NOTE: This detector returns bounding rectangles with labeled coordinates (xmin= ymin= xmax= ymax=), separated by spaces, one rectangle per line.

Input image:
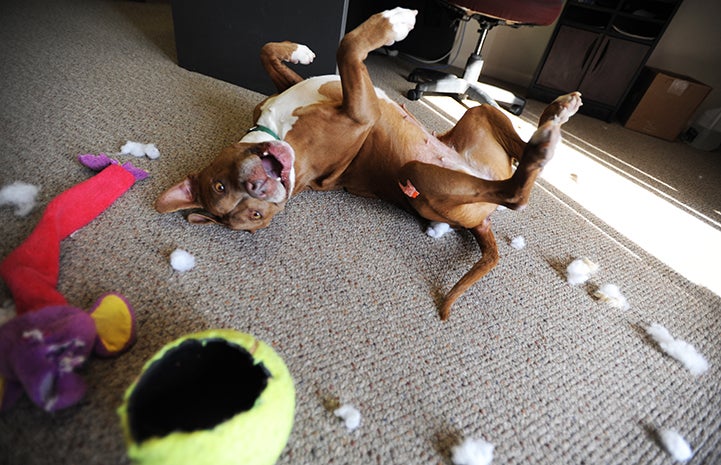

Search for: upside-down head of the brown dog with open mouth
xmin=155 ymin=141 xmax=295 ymax=232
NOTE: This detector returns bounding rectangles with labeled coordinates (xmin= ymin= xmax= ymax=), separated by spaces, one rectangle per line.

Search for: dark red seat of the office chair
xmin=448 ymin=0 xmax=563 ymax=26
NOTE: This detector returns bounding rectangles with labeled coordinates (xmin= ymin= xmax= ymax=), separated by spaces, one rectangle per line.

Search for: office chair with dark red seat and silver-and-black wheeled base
xmin=407 ymin=0 xmax=563 ymax=115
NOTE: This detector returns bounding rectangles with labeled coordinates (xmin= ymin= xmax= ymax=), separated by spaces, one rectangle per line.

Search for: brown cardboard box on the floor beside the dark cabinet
xmin=619 ymin=67 xmax=711 ymax=140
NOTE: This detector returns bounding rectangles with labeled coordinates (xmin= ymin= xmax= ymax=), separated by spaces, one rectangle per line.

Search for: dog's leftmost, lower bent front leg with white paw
xmin=260 ymin=42 xmax=315 ymax=92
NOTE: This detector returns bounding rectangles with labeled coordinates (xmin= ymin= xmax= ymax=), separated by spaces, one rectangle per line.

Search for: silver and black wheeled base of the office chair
xmin=407 ymin=68 xmax=526 ymax=115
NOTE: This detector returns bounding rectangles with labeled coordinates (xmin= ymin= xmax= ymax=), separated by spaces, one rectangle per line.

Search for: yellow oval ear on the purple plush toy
xmin=90 ymin=294 xmax=134 ymax=354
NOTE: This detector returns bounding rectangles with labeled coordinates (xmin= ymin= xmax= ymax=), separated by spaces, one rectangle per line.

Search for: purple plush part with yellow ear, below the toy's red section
xmin=0 ymin=294 xmax=135 ymax=412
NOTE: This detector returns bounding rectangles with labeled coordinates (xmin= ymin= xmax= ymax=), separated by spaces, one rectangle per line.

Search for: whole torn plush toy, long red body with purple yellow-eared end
xmin=0 ymin=159 xmax=147 ymax=411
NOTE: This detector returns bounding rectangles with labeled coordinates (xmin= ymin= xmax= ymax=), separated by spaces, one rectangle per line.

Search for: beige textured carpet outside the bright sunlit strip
xmin=0 ymin=0 xmax=721 ymax=465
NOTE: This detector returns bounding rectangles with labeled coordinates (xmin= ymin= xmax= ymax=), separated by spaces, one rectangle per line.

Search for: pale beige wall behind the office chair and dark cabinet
xmin=453 ymin=0 xmax=721 ymax=115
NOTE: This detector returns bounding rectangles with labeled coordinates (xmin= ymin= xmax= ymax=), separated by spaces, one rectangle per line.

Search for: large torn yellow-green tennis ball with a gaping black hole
xmin=118 ymin=330 xmax=295 ymax=465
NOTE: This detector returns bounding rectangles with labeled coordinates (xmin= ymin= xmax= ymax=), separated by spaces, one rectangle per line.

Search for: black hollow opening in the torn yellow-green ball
xmin=128 ymin=338 xmax=270 ymax=443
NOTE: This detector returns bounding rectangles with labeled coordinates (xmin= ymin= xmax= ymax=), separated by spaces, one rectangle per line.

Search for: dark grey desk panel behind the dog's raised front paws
xmin=171 ymin=0 xmax=348 ymax=94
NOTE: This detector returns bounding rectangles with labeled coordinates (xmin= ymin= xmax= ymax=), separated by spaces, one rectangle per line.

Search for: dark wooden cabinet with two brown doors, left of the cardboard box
xmin=528 ymin=0 xmax=681 ymax=121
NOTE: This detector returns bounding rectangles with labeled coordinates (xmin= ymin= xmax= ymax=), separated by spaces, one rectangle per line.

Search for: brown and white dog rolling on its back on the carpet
xmin=155 ymin=8 xmax=581 ymax=320
